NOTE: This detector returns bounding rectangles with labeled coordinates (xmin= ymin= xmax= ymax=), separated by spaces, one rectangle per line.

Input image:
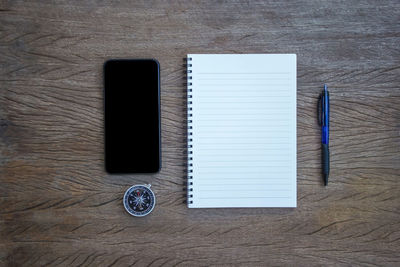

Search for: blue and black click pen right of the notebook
xmin=318 ymin=84 xmax=329 ymax=185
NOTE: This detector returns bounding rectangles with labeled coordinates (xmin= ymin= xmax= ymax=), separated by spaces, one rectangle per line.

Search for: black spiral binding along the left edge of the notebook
xmin=186 ymin=57 xmax=193 ymax=205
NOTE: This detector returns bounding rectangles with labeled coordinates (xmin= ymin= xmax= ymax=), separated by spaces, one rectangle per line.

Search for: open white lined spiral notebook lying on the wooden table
xmin=187 ymin=54 xmax=297 ymax=208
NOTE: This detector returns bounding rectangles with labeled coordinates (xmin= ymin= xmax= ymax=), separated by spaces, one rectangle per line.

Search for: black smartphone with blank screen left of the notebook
xmin=104 ymin=59 xmax=161 ymax=173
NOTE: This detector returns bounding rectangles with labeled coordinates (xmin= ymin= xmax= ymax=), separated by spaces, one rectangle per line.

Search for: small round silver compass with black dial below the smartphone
xmin=123 ymin=184 xmax=156 ymax=217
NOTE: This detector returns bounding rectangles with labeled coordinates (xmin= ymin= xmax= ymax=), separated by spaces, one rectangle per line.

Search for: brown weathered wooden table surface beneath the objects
xmin=0 ymin=0 xmax=400 ymax=266
